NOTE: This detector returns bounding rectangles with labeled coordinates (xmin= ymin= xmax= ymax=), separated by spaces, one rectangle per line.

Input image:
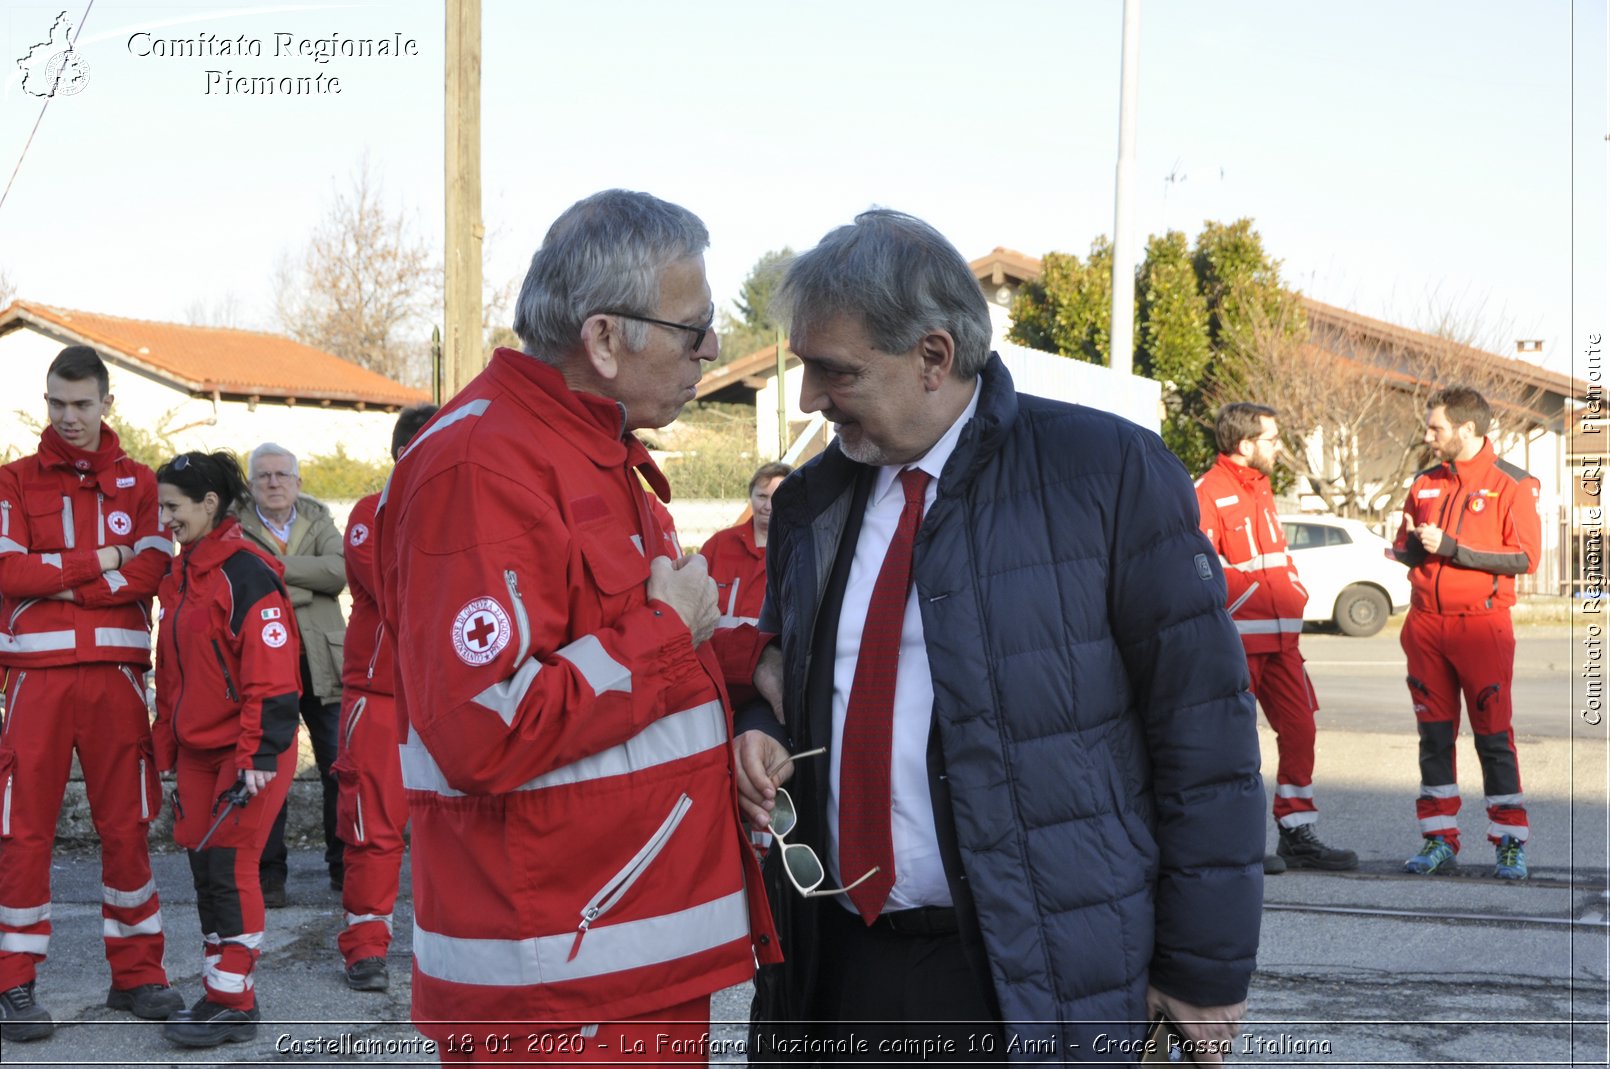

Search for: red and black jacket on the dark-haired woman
xmin=151 ymin=517 xmax=301 ymax=771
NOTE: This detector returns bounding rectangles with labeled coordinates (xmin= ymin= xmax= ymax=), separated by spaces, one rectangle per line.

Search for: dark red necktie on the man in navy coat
xmin=839 ymin=468 xmax=929 ymax=924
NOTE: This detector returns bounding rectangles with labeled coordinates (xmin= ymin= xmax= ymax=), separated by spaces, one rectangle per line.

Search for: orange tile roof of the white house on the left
xmin=0 ymin=301 xmax=430 ymax=406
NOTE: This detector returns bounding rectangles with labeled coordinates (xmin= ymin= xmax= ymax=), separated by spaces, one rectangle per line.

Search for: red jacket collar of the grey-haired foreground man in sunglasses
xmin=486 ymin=349 xmax=671 ymax=501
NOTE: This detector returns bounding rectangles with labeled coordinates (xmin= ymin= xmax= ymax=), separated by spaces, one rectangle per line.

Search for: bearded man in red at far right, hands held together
xmin=1393 ymin=386 xmax=1542 ymax=879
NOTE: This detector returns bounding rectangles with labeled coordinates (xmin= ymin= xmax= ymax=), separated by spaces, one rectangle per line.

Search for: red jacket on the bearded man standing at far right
xmin=1393 ymin=441 xmax=1542 ymax=615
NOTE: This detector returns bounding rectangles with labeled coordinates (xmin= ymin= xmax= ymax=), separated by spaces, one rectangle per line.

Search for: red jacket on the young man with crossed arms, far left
xmin=0 ymin=423 xmax=174 ymax=670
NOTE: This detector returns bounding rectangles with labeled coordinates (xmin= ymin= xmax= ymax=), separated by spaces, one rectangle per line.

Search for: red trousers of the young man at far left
xmin=0 ymin=663 xmax=167 ymax=990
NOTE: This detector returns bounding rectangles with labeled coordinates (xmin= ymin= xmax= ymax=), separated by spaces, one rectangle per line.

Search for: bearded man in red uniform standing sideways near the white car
xmin=1196 ymin=402 xmax=1359 ymax=874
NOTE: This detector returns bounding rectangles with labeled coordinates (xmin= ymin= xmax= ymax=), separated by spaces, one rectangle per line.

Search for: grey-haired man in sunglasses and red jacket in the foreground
xmin=375 ymin=190 xmax=779 ymax=1064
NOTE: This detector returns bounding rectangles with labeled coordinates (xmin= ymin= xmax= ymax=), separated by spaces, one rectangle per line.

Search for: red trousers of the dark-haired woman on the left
xmin=174 ymin=734 xmax=296 ymax=1009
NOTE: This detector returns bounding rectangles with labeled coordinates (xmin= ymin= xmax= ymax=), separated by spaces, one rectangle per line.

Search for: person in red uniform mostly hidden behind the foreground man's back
xmin=335 ymin=404 xmax=436 ymax=992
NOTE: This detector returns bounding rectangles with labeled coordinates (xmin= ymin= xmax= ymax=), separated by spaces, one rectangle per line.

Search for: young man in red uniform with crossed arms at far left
xmin=0 ymin=346 xmax=184 ymax=1042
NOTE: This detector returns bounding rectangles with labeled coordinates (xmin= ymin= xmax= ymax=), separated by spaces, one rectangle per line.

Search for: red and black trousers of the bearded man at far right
xmin=1399 ymin=609 xmax=1530 ymax=853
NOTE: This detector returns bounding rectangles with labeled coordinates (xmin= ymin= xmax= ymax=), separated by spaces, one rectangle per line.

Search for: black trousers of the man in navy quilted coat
xmin=815 ymin=902 xmax=1006 ymax=1066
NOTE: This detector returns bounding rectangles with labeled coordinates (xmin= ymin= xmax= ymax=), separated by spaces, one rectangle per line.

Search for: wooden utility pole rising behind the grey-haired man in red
xmin=443 ymin=0 xmax=486 ymax=401
